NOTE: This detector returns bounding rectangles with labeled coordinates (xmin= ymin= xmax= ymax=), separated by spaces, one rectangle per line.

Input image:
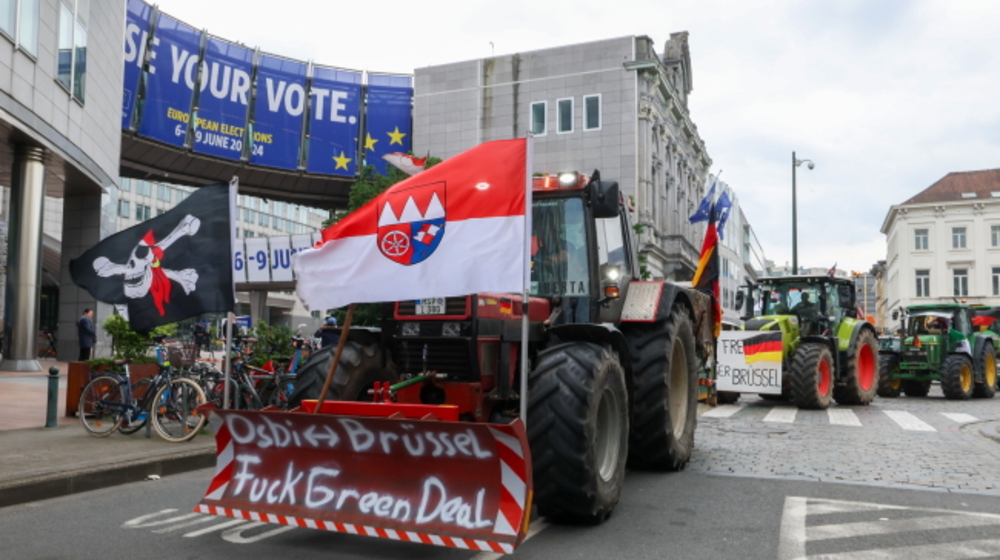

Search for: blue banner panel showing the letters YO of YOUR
xmin=139 ymin=14 xmax=201 ymax=147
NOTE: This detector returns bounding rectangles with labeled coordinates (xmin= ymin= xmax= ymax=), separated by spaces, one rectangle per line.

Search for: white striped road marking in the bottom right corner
xmin=778 ymin=496 xmax=1000 ymax=560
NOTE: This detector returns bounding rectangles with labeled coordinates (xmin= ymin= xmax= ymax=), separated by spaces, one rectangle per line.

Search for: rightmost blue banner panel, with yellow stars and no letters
xmin=364 ymin=74 xmax=413 ymax=175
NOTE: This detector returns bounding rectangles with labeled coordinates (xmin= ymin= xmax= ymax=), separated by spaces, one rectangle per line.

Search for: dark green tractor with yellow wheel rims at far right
xmin=878 ymin=303 xmax=1000 ymax=400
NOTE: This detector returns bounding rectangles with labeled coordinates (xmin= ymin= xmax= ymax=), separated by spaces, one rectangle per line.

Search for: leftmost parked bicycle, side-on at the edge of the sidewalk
xmin=78 ymin=350 xmax=208 ymax=442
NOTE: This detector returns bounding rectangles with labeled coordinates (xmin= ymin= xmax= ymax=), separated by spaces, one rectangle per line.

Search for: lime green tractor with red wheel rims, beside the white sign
xmin=737 ymin=275 xmax=879 ymax=409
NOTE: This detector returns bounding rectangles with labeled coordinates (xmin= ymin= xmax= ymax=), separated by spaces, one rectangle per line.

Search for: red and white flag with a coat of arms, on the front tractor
xmin=292 ymin=139 xmax=531 ymax=310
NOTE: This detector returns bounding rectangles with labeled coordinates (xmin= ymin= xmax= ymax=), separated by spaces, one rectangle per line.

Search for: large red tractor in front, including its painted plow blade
xmin=199 ymin=172 xmax=715 ymax=551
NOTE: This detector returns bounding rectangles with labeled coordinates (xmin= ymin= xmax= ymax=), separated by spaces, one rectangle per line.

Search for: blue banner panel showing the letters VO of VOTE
xmin=250 ymin=55 xmax=307 ymax=169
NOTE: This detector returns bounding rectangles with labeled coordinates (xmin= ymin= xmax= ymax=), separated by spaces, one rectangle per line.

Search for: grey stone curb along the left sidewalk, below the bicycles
xmin=0 ymin=448 xmax=215 ymax=508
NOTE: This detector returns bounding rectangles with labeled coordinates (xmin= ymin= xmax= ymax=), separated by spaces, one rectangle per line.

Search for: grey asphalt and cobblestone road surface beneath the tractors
xmin=0 ymin=384 xmax=1000 ymax=560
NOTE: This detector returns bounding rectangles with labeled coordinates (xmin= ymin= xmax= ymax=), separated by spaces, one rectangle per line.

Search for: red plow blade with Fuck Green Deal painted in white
xmin=194 ymin=401 xmax=532 ymax=553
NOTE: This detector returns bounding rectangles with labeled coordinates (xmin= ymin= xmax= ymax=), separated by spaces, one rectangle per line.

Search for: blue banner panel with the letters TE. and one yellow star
xmin=306 ymin=66 xmax=362 ymax=177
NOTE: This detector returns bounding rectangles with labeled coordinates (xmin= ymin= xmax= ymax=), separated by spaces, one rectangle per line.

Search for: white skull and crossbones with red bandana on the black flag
xmin=94 ymin=214 xmax=201 ymax=317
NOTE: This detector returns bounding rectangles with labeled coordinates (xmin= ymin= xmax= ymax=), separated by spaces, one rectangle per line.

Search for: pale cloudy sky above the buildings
xmin=158 ymin=0 xmax=1000 ymax=271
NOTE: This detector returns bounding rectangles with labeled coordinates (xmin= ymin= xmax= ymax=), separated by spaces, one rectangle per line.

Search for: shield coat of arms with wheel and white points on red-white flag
xmin=377 ymin=182 xmax=446 ymax=265
